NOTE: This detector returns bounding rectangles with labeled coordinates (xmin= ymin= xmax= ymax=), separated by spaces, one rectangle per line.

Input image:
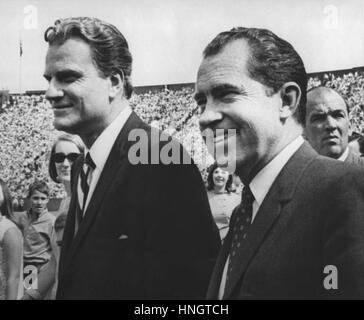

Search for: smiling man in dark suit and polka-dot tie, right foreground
xmin=195 ymin=27 xmax=364 ymax=299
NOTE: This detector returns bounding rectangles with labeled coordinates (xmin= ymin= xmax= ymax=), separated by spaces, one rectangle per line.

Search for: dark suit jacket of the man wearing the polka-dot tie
xmin=207 ymin=143 xmax=364 ymax=299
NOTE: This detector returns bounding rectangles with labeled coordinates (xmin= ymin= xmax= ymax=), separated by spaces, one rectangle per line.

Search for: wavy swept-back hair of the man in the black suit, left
xmin=44 ymin=17 xmax=133 ymax=99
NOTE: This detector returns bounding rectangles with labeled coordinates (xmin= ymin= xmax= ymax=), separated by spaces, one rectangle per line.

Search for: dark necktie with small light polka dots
xmin=226 ymin=186 xmax=254 ymax=288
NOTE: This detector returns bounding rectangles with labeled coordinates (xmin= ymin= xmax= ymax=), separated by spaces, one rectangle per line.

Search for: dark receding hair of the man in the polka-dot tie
xmin=203 ymin=27 xmax=307 ymax=125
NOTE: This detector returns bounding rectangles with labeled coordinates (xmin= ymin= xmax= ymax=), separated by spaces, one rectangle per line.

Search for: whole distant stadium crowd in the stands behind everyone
xmin=0 ymin=72 xmax=364 ymax=201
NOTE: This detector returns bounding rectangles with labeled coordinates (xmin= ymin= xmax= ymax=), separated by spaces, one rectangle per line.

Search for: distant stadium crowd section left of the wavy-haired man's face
xmin=0 ymin=96 xmax=59 ymax=199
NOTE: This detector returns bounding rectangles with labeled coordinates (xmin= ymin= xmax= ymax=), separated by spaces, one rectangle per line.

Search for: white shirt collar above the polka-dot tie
xmin=249 ymin=136 xmax=304 ymax=206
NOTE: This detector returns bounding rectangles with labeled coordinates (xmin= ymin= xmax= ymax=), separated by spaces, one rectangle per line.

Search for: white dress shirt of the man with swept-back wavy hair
xmin=77 ymin=105 xmax=132 ymax=214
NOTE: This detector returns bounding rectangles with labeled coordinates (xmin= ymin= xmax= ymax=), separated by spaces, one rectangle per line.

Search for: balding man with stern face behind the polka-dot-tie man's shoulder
xmin=305 ymin=87 xmax=364 ymax=165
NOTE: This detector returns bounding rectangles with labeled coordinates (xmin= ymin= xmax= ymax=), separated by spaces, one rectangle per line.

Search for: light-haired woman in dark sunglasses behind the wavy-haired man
xmin=49 ymin=133 xmax=85 ymax=246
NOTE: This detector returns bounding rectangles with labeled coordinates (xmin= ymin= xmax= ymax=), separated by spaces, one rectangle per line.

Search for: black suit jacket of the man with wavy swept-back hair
xmin=57 ymin=113 xmax=220 ymax=299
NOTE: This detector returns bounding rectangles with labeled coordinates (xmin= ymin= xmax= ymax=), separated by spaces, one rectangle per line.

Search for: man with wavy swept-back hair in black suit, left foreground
xmin=44 ymin=17 xmax=219 ymax=299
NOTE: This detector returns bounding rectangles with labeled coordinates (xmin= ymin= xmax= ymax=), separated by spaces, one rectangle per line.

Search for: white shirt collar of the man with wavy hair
xmin=85 ymin=105 xmax=132 ymax=171
